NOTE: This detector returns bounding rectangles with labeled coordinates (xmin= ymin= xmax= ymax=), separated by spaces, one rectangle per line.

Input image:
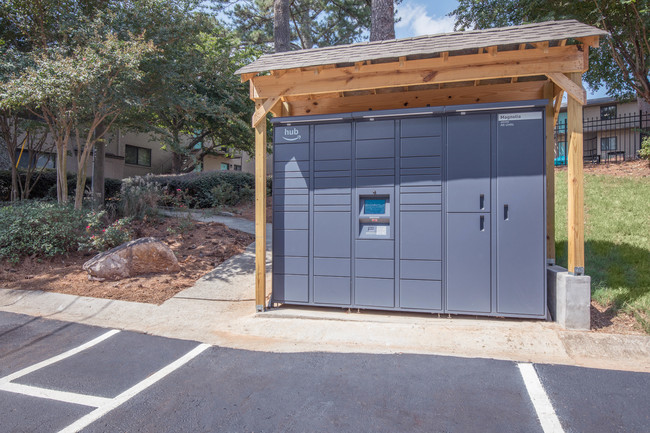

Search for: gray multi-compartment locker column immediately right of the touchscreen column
xmin=399 ymin=116 xmax=443 ymax=311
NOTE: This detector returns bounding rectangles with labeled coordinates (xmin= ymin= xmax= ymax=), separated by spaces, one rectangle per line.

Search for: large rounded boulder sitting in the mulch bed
xmin=83 ymin=238 xmax=181 ymax=281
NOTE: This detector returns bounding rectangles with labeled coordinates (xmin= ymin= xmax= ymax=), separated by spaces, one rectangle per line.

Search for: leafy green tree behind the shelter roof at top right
xmin=450 ymin=0 xmax=650 ymax=102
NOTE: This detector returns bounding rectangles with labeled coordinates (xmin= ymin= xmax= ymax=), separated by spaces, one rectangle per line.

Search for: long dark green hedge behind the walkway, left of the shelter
xmin=124 ymin=171 xmax=255 ymax=208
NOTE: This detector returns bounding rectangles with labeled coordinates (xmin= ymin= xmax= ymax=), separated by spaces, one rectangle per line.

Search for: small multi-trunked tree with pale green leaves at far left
xmin=0 ymin=11 xmax=153 ymax=209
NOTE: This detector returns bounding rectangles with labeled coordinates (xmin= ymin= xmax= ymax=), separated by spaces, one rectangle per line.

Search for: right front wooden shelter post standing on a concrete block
xmin=567 ymin=72 xmax=585 ymax=275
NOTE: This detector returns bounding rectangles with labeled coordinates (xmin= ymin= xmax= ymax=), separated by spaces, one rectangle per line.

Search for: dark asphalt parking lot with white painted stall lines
xmin=0 ymin=312 xmax=650 ymax=432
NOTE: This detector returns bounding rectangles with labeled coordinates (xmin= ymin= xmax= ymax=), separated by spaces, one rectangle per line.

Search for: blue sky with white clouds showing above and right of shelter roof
xmin=395 ymin=0 xmax=607 ymax=99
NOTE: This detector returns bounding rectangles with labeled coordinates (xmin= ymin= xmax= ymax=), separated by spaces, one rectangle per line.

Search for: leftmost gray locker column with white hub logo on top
xmin=273 ymin=126 xmax=310 ymax=303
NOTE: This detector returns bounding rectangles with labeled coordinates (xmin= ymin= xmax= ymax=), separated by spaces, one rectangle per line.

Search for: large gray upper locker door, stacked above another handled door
xmin=447 ymin=114 xmax=491 ymax=212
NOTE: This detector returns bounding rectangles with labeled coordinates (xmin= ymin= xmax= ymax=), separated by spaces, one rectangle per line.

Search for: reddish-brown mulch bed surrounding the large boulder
xmin=0 ymin=218 xmax=254 ymax=304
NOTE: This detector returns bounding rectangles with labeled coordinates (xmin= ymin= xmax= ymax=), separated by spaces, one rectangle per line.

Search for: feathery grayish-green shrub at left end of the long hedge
xmin=120 ymin=176 xmax=162 ymax=219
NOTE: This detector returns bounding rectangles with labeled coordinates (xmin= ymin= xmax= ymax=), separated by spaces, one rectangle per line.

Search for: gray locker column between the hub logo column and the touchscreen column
xmin=312 ymin=122 xmax=352 ymax=305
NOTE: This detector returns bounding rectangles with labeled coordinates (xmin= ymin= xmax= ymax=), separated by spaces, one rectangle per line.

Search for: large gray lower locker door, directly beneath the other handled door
xmin=447 ymin=213 xmax=491 ymax=313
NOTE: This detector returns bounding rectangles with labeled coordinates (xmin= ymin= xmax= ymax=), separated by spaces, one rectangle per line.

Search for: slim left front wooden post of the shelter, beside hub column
xmin=255 ymin=107 xmax=266 ymax=311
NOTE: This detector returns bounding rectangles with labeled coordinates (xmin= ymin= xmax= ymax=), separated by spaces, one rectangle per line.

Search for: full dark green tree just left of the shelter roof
xmin=130 ymin=0 xmax=254 ymax=173
